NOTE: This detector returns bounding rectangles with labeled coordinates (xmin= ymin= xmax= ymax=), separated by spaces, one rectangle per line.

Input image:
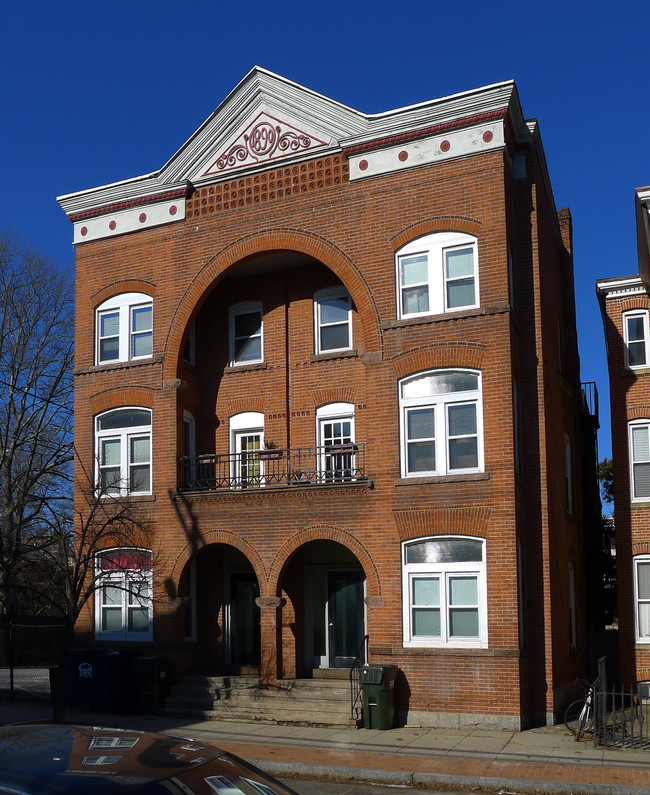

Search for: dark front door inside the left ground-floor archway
xmin=229 ymin=572 xmax=260 ymax=666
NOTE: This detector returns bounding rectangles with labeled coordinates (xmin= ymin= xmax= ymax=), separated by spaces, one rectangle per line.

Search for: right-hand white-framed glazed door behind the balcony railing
xmin=316 ymin=403 xmax=357 ymax=483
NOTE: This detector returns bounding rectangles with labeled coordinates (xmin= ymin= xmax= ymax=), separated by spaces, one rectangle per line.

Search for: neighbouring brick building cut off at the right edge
xmin=596 ymin=188 xmax=650 ymax=685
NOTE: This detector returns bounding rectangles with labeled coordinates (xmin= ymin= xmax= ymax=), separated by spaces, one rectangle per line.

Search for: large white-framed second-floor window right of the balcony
xmin=399 ymin=369 xmax=483 ymax=477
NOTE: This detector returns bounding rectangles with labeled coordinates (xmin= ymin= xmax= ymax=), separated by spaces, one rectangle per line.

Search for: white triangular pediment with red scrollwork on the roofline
xmin=160 ymin=68 xmax=368 ymax=185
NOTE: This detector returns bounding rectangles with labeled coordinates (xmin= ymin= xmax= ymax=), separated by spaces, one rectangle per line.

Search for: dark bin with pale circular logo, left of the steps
xmin=67 ymin=649 xmax=135 ymax=712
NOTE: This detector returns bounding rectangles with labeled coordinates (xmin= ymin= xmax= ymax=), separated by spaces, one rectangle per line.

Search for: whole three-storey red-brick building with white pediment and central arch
xmin=60 ymin=68 xmax=594 ymax=728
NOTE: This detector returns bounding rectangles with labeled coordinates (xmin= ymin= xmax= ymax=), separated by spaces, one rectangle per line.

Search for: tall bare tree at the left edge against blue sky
xmin=0 ymin=236 xmax=73 ymax=632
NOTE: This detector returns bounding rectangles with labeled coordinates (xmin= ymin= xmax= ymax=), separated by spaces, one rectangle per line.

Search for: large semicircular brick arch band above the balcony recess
xmin=164 ymin=229 xmax=382 ymax=378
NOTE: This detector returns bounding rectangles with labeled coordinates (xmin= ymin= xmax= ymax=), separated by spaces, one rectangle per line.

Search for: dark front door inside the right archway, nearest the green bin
xmin=327 ymin=571 xmax=364 ymax=668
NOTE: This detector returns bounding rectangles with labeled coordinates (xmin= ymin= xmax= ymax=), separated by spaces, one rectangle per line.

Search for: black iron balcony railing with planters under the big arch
xmin=180 ymin=444 xmax=368 ymax=493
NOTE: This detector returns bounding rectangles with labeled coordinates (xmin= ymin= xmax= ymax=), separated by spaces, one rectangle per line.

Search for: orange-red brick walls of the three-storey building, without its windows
xmin=61 ymin=70 xmax=592 ymax=727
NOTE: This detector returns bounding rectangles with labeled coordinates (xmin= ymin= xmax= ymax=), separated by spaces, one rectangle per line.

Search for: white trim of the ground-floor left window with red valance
xmin=95 ymin=547 xmax=153 ymax=643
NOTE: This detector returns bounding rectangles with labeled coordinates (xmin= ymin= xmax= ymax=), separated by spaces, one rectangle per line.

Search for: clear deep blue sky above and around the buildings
xmin=0 ymin=0 xmax=650 ymax=455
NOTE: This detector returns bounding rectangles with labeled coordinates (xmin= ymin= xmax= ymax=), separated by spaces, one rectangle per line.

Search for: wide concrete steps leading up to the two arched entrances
xmin=163 ymin=676 xmax=357 ymax=728
